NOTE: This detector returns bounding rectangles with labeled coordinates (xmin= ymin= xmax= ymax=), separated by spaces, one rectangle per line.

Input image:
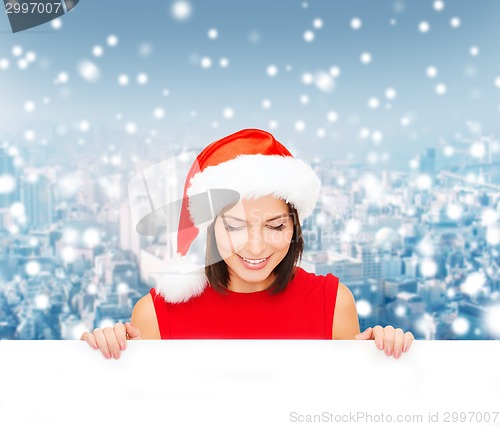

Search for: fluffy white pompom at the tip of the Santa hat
xmin=154 ymin=255 xmax=208 ymax=303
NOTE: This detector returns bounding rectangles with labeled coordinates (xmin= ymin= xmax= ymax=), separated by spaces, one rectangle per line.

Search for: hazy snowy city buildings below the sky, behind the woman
xmin=0 ymin=131 xmax=500 ymax=339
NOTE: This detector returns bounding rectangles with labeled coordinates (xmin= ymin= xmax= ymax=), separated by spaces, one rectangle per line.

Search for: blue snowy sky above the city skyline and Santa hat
xmin=0 ymin=0 xmax=500 ymax=167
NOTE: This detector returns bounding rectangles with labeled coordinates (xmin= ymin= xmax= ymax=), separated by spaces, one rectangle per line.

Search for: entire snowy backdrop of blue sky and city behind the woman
xmin=0 ymin=0 xmax=500 ymax=340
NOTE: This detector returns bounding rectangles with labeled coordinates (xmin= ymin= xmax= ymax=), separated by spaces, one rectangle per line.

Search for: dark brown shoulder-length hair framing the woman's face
xmin=205 ymin=203 xmax=304 ymax=294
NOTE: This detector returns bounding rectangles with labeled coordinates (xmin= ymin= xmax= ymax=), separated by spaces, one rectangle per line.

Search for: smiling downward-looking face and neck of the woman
xmin=215 ymin=196 xmax=293 ymax=292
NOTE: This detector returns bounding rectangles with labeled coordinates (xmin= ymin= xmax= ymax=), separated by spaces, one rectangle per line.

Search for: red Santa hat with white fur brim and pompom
xmin=155 ymin=129 xmax=320 ymax=303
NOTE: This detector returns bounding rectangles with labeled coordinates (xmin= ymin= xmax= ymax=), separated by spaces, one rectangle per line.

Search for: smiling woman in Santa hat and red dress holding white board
xmin=81 ymin=129 xmax=414 ymax=359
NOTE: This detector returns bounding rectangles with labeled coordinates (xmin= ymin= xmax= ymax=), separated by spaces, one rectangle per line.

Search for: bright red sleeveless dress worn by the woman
xmin=146 ymin=268 xmax=339 ymax=340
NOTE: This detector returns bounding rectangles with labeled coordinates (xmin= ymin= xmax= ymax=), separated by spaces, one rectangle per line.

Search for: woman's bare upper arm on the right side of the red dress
xmin=332 ymin=282 xmax=359 ymax=340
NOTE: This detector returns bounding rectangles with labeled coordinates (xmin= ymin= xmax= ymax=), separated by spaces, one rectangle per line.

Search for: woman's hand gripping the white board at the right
xmin=354 ymin=325 xmax=415 ymax=359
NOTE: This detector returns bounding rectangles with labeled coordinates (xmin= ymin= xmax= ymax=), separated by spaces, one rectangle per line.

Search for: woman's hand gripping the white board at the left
xmin=80 ymin=322 xmax=141 ymax=359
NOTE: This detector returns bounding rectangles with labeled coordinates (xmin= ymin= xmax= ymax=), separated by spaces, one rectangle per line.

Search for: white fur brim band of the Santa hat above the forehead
xmin=187 ymin=154 xmax=321 ymax=223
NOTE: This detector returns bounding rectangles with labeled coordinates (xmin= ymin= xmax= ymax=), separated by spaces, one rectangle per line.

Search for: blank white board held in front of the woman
xmin=0 ymin=340 xmax=500 ymax=426
